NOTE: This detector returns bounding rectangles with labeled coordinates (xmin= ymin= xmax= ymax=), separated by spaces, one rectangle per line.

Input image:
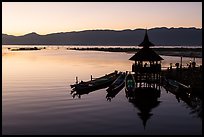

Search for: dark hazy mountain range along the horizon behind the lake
xmin=2 ymin=27 xmax=202 ymax=46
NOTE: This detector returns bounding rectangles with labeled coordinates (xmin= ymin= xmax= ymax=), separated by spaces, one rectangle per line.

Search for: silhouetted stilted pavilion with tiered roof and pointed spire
xmin=129 ymin=30 xmax=163 ymax=87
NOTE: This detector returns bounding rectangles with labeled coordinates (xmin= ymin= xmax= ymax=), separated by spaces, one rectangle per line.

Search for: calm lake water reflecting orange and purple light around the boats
xmin=2 ymin=47 xmax=202 ymax=135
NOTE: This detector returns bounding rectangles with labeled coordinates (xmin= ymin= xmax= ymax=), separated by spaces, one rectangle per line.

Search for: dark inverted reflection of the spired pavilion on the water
xmin=126 ymin=88 xmax=161 ymax=129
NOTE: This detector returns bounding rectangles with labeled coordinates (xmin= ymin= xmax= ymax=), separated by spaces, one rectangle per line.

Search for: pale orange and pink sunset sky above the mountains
xmin=2 ymin=2 xmax=202 ymax=36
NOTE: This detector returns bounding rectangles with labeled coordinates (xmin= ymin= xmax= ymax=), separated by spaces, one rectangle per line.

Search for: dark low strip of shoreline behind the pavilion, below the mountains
xmin=67 ymin=47 xmax=202 ymax=58
